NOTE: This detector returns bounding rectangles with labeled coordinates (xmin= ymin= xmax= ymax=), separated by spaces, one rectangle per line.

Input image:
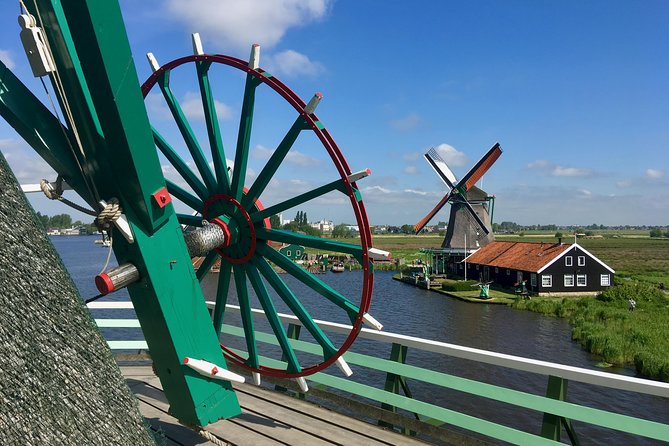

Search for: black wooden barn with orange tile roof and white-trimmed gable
xmin=458 ymin=241 xmax=615 ymax=296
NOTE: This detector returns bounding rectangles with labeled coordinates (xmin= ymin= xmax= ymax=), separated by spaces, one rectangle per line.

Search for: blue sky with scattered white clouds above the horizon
xmin=0 ymin=0 xmax=669 ymax=225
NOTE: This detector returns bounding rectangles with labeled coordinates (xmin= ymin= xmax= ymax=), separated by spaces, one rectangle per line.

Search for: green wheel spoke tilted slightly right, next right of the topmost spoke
xmin=230 ymin=74 xmax=260 ymax=201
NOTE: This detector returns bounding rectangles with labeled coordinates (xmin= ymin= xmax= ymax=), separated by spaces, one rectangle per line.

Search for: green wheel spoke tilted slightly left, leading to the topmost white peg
xmin=195 ymin=61 xmax=230 ymax=194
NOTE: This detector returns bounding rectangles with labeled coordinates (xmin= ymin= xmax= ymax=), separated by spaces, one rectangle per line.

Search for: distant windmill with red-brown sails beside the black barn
xmin=414 ymin=143 xmax=502 ymax=250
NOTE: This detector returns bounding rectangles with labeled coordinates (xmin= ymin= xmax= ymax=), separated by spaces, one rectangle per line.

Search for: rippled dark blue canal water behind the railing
xmin=52 ymin=237 xmax=669 ymax=445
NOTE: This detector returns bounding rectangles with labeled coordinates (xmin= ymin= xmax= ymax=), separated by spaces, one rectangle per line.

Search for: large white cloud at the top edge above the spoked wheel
xmin=167 ymin=0 xmax=332 ymax=52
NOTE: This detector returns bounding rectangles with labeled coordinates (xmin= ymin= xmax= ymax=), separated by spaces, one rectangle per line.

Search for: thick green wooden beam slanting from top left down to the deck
xmin=5 ymin=0 xmax=241 ymax=425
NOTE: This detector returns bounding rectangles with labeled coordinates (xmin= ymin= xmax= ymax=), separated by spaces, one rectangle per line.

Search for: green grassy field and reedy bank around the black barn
xmin=328 ymin=231 xmax=669 ymax=382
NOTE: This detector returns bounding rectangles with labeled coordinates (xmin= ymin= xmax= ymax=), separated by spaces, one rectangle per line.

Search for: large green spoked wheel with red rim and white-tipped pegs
xmin=142 ymin=42 xmax=379 ymax=378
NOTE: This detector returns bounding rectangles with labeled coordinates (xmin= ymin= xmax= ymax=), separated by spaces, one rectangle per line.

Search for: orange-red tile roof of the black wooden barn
xmin=467 ymin=242 xmax=571 ymax=272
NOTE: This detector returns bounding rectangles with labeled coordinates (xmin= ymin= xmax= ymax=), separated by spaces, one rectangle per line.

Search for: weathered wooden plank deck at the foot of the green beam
xmin=121 ymin=366 xmax=427 ymax=446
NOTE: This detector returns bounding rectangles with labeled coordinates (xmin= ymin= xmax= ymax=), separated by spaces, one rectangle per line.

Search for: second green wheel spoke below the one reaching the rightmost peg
xmin=251 ymin=256 xmax=337 ymax=359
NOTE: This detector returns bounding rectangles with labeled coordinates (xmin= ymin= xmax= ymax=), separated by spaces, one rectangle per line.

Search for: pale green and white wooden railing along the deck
xmin=89 ymin=302 xmax=669 ymax=445
